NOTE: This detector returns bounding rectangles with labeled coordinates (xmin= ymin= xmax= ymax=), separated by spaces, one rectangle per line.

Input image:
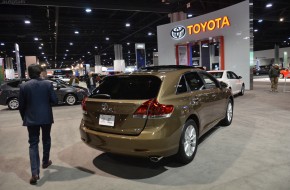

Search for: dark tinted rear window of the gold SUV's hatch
xmin=90 ymin=75 xmax=161 ymax=100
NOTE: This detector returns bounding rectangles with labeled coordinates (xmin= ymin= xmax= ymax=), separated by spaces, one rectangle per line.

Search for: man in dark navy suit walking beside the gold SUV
xmin=19 ymin=64 xmax=57 ymax=185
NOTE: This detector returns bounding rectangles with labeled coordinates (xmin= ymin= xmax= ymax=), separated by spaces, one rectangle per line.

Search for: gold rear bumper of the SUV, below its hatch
xmin=80 ymin=120 xmax=180 ymax=157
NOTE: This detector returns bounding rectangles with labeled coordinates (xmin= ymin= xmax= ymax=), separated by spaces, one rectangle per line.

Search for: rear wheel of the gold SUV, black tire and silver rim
xmin=176 ymin=119 xmax=198 ymax=164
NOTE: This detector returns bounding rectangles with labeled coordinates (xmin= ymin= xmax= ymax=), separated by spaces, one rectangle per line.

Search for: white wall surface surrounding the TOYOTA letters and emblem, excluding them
xmin=157 ymin=0 xmax=250 ymax=90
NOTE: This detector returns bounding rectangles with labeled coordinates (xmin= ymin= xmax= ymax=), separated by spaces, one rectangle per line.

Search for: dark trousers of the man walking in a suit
xmin=27 ymin=124 xmax=51 ymax=175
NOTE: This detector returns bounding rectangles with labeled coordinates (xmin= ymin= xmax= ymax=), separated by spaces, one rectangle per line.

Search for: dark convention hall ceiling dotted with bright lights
xmin=0 ymin=0 xmax=290 ymax=67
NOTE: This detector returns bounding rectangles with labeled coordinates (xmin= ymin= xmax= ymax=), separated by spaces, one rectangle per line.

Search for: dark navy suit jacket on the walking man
xmin=19 ymin=78 xmax=57 ymax=126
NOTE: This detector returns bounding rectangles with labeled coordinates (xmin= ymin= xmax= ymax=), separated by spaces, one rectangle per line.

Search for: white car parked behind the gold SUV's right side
xmin=208 ymin=70 xmax=245 ymax=96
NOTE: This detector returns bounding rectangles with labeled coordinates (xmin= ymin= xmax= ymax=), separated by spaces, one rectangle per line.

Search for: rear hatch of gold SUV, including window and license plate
xmin=83 ymin=75 xmax=162 ymax=135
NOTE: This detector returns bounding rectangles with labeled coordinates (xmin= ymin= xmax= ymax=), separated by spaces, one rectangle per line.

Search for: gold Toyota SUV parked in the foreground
xmin=80 ymin=65 xmax=234 ymax=164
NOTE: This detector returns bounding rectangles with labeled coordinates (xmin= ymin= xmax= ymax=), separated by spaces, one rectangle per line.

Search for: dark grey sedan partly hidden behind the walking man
xmin=0 ymin=79 xmax=88 ymax=110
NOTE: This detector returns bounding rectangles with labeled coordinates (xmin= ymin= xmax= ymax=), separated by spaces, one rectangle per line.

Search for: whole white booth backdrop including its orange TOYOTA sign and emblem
xmin=157 ymin=0 xmax=253 ymax=90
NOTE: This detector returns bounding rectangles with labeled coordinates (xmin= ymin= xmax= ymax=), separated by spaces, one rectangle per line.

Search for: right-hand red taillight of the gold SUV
xmin=133 ymin=99 xmax=174 ymax=118
